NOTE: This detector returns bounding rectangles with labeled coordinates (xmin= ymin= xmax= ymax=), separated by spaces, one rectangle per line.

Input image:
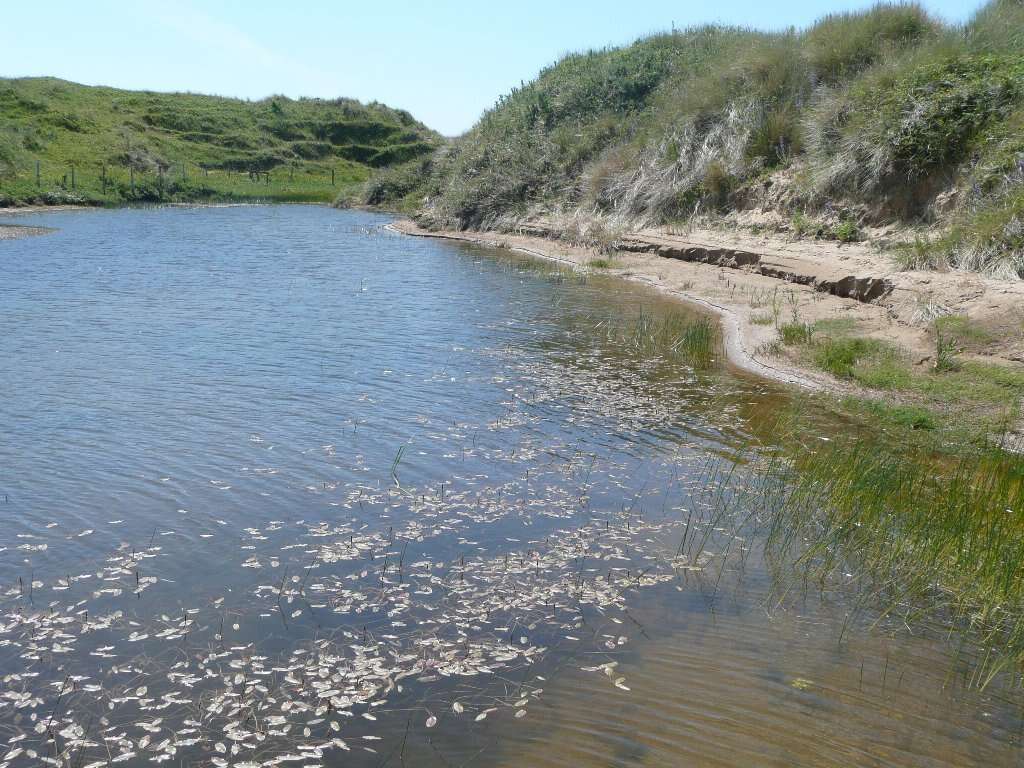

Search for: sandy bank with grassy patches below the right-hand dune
xmin=388 ymin=218 xmax=1024 ymax=421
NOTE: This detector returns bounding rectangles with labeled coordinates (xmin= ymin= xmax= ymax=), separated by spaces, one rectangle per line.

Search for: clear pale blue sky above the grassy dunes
xmin=0 ymin=0 xmax=983 ymax=134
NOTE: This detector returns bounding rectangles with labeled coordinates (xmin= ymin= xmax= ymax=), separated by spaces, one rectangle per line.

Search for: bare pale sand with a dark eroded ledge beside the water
xmin=391 ymin=220 xmax=1024 ymax=394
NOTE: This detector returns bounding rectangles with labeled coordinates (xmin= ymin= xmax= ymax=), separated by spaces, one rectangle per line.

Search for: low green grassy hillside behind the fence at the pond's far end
xmin=0 ymin=78 xmax=438 ymax=206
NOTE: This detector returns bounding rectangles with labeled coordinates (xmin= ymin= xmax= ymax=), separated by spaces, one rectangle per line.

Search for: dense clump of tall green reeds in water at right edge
xmin=730 ymin=440 xmax=1024 ymax=687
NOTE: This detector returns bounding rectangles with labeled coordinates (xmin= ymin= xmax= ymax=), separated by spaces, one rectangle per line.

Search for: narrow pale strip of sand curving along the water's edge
xmin=385 ymin=219 xmax=831 ymax=393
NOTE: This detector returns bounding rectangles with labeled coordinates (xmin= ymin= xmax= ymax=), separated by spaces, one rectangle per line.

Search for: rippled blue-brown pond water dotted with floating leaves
xmin=0 ymin=206 xmax=1021 ymax=766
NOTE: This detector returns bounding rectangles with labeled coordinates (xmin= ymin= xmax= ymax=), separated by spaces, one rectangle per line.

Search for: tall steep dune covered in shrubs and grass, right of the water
xmin=364 ymin=0 xmax=1024 ymax=276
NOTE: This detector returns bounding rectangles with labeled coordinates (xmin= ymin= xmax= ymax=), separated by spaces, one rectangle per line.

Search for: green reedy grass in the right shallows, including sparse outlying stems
xmin=679 ymin=398 xmax=1024 ymax=688
